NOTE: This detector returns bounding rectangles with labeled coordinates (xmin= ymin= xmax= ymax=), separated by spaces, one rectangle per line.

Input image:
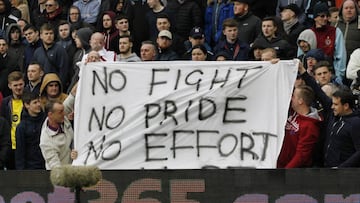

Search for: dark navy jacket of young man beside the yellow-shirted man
xmin=15 ymin=110 xmax=46 ymax=170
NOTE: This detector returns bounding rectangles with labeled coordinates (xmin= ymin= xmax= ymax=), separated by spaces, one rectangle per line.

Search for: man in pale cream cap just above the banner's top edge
xmin=156 ymin=30 xmax=179 ymax=61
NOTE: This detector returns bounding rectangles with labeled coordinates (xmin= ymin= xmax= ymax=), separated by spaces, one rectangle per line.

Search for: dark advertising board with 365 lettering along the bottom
xmin=0 ymin=168 xmax=360 ymax=203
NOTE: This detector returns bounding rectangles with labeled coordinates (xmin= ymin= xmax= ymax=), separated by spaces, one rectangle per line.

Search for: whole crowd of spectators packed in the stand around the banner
xmin=0 ymin=0 xmax=360 ymax=170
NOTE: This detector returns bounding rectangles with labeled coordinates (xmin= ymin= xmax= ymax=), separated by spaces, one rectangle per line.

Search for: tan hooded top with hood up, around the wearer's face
xmin=40 ymin=73 xmax=67 ymax=109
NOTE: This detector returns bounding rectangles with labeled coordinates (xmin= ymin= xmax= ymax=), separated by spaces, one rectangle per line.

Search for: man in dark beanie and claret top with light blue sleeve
xmin=311 ymin=2 xmax=346 ymax=83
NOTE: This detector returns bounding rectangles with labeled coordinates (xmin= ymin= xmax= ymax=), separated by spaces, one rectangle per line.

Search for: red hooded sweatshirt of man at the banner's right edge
xmin=277 ymin=107 xmax=322 ymax=168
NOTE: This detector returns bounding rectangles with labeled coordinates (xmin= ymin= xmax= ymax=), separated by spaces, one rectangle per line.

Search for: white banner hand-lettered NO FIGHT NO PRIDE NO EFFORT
xmin=74 ymin=61 xmax=298 ymax=169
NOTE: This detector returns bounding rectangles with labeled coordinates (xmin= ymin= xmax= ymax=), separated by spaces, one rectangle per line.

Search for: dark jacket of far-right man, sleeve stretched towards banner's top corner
xmin=302 ymin=73 xmax=360 ymax=167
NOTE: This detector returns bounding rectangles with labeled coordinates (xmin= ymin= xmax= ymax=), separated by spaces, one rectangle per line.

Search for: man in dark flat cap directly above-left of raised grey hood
xmin=280 ymin=4 xmax=305 ymax=47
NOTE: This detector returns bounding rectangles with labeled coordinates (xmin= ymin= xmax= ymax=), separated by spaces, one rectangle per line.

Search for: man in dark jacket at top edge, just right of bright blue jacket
xmin=233 ymin=0 xmax=261 ymax=44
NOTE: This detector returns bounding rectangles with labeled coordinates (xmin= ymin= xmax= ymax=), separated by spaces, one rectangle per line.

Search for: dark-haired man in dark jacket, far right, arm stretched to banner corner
xmin=299 ymin=64 xmax=360 ymax=167
